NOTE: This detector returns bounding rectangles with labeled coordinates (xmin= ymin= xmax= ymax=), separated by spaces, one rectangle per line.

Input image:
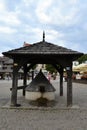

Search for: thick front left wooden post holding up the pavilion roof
xmin=11 ymin=63 xmax=18 ymax=106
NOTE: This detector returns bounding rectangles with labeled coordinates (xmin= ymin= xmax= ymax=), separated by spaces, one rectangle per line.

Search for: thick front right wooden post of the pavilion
xmin=66 ymin=65 xmax=72 ymax=106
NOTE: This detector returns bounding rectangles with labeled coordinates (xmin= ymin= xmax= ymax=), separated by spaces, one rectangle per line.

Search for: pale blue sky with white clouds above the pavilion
xmin=0 ymin=0 xmax=87 ymax=55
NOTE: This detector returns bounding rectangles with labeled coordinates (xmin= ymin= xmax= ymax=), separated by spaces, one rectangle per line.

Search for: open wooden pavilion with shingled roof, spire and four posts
xmin=3 ymin=33 xmax=83 ymax=106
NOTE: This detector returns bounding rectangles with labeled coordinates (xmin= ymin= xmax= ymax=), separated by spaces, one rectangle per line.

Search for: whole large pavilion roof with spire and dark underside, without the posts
xmin=3 ymin=35 xmax=83 ymax=66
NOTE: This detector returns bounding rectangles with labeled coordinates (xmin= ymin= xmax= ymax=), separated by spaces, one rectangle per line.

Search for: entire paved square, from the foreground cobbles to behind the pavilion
xmin=0 ymin=81 xmax=87 ymax=130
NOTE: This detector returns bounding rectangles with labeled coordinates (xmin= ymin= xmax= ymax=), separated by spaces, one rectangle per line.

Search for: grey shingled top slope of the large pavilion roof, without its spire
xmin=3 ymin=41 xmax=83 ymax=56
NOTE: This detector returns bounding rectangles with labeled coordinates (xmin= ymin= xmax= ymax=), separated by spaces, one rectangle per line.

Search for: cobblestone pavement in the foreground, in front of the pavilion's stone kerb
xmin=0 ymin=109 xmax=87 ymax=130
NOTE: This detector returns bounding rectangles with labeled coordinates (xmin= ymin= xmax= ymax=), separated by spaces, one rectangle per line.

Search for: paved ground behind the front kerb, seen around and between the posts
xmin=0 ymin=80 xmax=87 ymax=108
